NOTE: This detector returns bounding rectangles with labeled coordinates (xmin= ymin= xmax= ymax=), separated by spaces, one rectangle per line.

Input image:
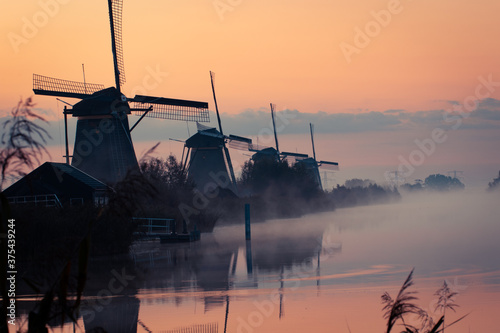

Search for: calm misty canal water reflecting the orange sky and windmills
xmin=13 ymin=191 xmax=500 ymax=333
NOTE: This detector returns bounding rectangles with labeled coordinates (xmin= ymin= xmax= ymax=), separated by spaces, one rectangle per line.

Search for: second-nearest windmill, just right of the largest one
xmin=183 ymin=72 xmax=252 ymax=195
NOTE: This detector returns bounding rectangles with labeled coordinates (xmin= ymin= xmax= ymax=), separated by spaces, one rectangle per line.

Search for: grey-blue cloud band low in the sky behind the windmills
xmin=0 ymin=98 xmax=500 ymax=144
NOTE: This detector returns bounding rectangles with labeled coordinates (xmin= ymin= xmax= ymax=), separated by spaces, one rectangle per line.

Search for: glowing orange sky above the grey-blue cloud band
xmin=0 ymin=0 xmax=500 ymax=184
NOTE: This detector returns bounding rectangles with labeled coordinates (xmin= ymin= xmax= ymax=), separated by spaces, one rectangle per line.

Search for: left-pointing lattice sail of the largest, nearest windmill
xmin=33 ymin=74 xmax=104 ymax=99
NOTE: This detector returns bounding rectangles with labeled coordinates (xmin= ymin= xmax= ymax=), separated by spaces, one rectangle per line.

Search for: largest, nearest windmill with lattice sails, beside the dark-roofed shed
xmin=33 ymin=0 xmax=209 ymax=183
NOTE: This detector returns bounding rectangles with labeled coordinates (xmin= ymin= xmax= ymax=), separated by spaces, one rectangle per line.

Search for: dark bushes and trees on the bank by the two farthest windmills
xmin=235 ymin=159 xmax=400 ymax=217
